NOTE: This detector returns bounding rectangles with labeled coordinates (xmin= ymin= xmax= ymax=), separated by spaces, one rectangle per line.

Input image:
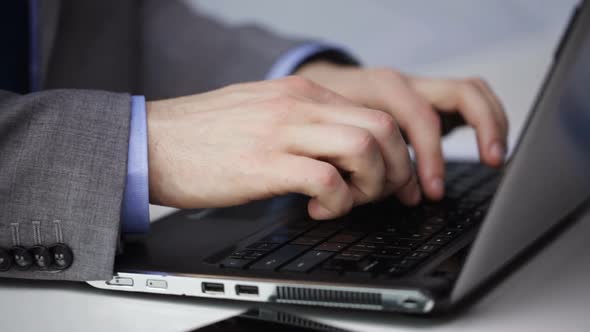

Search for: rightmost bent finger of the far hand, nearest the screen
xmin=414 ymin=78 xmax=506 ymax=166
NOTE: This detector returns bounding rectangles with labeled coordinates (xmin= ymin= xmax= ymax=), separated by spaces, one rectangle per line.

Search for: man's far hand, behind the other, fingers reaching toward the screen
xmin=297 ymin=62 xmax=508 ymax=199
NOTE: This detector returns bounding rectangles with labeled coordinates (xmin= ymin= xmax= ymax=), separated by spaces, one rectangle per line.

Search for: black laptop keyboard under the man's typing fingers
xmin=220 ymin=162 xmax=500 ymax=278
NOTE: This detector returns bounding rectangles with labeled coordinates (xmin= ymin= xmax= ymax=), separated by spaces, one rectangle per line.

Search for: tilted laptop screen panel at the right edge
xmin=451 ymin=2 xmax=590 ymax=300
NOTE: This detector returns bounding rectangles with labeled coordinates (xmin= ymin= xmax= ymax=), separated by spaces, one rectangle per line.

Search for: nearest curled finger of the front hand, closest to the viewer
xmin=268 ymin=154 xmax=354 ymax=220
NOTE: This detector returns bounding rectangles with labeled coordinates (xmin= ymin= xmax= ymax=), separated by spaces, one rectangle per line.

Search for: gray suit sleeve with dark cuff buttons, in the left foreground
xmin=0 ymin=90 xmax=130 ymax=280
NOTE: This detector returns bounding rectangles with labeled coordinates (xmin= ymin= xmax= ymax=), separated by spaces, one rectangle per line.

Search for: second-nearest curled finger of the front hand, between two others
xmin=281 ymin=124 xmax=385 ymax=204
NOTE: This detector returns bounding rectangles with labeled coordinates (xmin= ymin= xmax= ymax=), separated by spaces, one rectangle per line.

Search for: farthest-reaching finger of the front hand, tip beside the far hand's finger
xmin=307 ymin=105 xmax=421 ymax=205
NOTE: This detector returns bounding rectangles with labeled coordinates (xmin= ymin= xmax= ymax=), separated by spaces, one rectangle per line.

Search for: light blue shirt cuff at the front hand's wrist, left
xmin=121 ymin=96 xmax=150 ymax=234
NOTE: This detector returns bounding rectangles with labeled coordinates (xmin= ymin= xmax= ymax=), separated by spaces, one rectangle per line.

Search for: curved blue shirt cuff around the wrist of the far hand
xmin=266 ymin=42 xmax=359 ymax=80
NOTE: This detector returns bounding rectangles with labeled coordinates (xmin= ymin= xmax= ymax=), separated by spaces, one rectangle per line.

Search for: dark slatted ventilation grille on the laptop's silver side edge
xmin=277 ymin=286 xmax=382 ymax=309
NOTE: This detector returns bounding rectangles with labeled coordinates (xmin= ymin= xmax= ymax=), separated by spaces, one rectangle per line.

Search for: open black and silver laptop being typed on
xmin=89 ymin=3 xmax=590 ymax=314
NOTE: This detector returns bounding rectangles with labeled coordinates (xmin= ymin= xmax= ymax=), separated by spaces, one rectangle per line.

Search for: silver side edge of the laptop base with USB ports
xmin=88 ymin=272 xmax=435 ymax=314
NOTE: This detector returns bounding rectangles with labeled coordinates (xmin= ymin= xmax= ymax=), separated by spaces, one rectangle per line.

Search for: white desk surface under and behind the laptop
xmin=0 ymin=15 xmax=590 ymax=331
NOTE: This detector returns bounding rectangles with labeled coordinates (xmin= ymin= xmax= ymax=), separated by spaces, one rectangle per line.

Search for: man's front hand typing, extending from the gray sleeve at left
xmin=147 ymin=77 xmax=421 ymax=219
